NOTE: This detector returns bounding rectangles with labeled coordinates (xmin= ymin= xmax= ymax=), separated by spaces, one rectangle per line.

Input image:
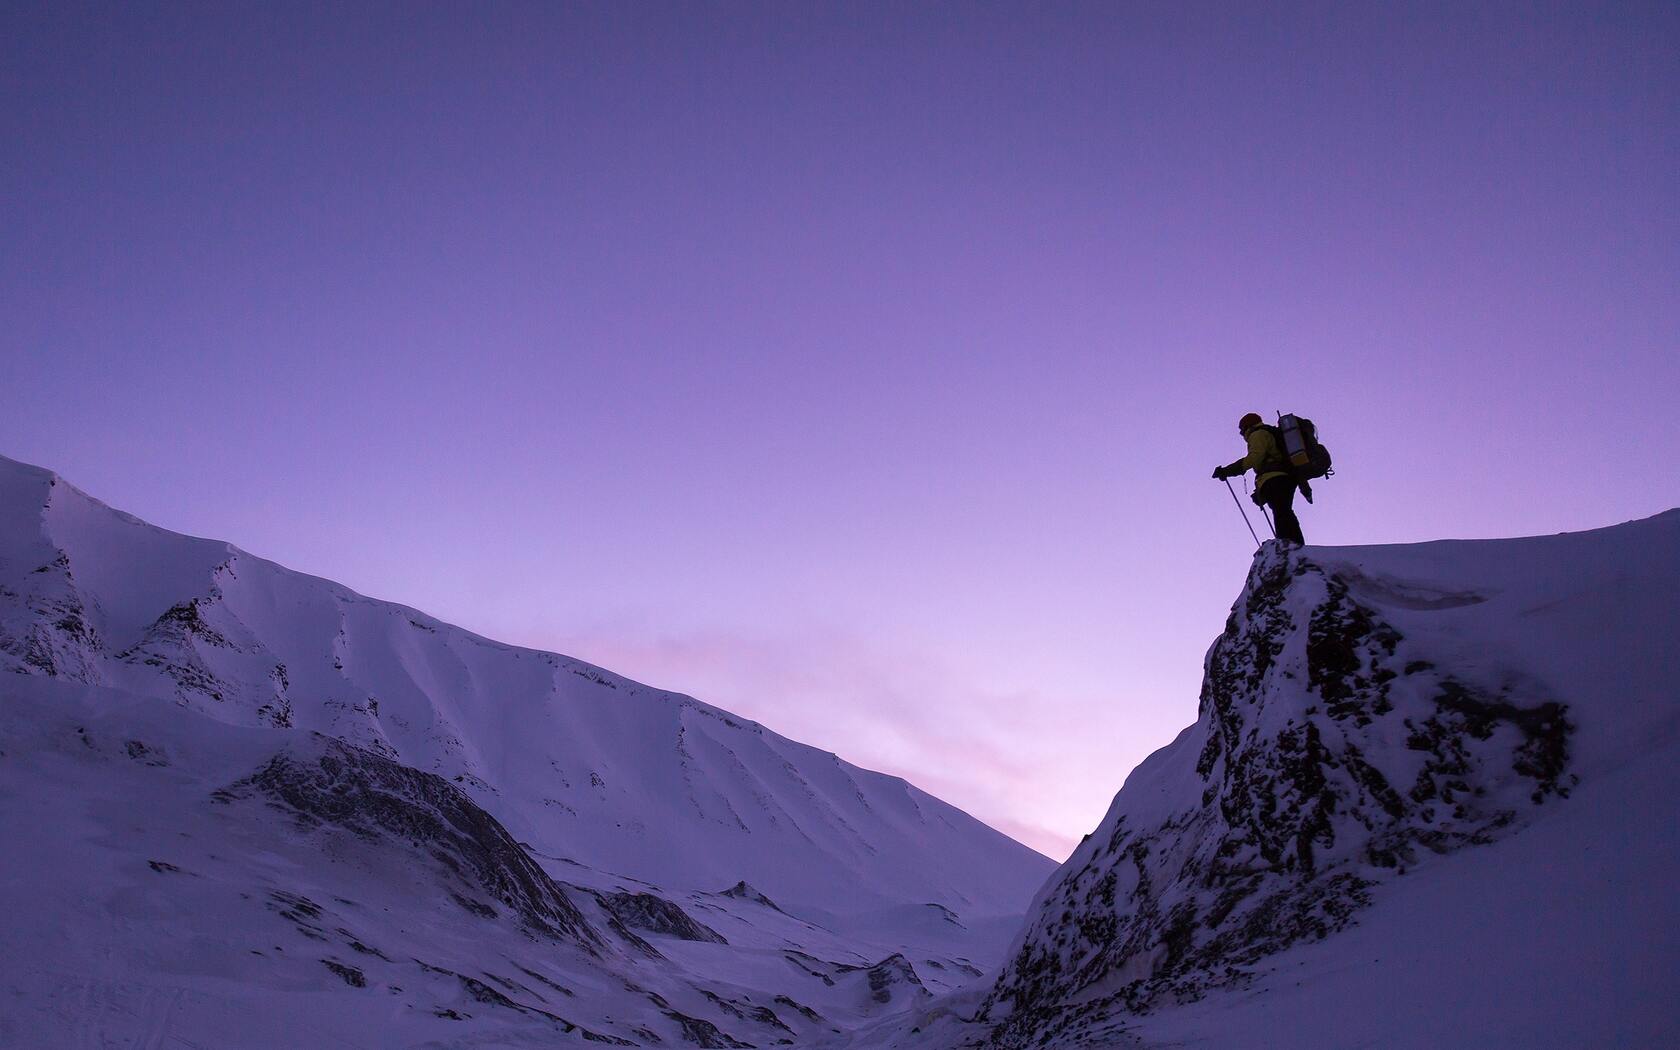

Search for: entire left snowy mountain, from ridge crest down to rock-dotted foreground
xmin=0 ymin=459 xmax=1053 ymax=1047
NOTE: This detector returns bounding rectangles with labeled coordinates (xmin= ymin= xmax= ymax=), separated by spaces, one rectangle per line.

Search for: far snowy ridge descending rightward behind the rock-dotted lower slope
xmin=0 ymin=459 xmax=1052 ymax=924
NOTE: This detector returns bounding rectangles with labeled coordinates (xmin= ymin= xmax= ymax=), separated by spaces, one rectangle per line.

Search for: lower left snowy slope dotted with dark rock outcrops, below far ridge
xmin=0 ymin=675 xmax=979 ymax=1050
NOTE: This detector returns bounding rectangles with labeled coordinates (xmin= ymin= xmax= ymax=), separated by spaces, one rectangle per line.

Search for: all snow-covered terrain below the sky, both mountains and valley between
xmin=0 ymin=460 xmax=1680 ymax=1050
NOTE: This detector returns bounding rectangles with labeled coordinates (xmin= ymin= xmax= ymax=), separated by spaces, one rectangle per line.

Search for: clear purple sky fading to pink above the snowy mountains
xmin=0 ymin=3 xmax=1680 ymax=855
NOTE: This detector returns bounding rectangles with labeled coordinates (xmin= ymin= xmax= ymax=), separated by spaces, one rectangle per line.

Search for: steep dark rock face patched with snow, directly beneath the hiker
xmin=981 ymin=544 xmax=1572 ymax=1048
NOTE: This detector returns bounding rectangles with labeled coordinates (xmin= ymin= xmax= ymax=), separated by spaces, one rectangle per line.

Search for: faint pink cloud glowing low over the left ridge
xmin=543 ymin=628 xmax=1124 ymax=858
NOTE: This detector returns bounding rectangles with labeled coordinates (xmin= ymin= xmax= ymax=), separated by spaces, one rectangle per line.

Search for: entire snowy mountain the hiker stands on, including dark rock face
xmin=835 ymin=511 xmax=1680 ymax=1050
